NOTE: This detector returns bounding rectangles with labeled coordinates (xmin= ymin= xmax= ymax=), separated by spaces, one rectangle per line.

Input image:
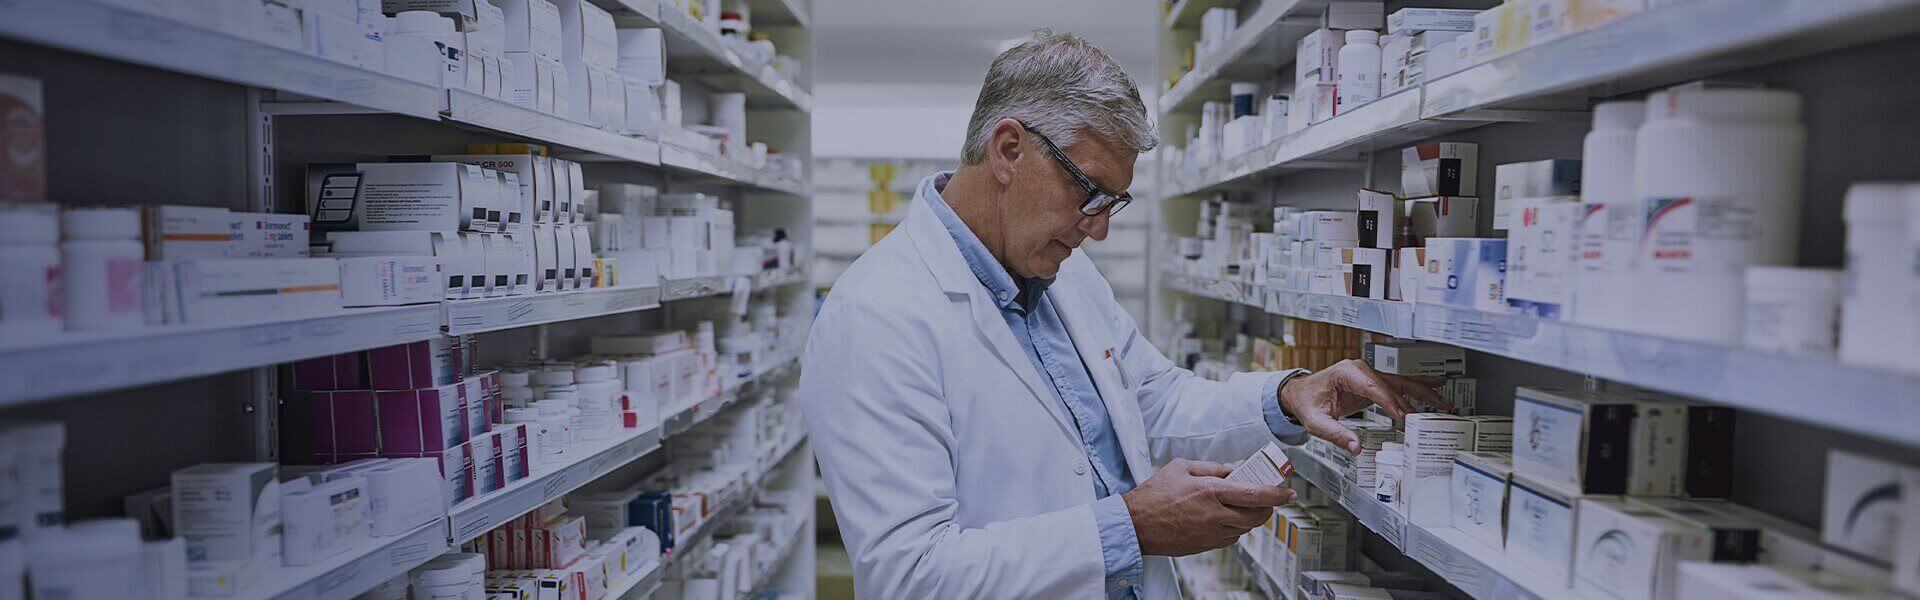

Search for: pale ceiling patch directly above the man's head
xmin=814 ymin=0 xmax=1160 ymax=87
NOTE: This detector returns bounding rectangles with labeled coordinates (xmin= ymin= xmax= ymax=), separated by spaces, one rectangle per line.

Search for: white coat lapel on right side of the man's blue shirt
xmin=1048 ymin=279 xmax=1154 ymax=483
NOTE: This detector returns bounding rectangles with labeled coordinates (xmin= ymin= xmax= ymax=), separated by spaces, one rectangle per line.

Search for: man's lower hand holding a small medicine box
xmin=1119 ymin=460 xmax=1294 ymax=556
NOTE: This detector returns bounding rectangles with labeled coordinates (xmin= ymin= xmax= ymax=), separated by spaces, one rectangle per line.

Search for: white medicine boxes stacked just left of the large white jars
xmin=1494 ymin=160 xmax=1582 ymax=319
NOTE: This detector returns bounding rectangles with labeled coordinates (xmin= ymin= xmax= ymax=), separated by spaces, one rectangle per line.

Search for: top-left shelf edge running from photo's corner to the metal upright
xmin=0 ymin=0 xmax=445 ymax=119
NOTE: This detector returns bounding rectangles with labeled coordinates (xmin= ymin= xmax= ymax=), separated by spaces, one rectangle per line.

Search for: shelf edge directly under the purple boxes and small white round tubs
xmin=449 ymin=427 xmax=662 ymax=544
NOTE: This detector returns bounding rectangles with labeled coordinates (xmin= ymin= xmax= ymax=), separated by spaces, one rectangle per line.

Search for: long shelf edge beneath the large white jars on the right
xmin=1162 ymin=271 xmax=1920 ymax=446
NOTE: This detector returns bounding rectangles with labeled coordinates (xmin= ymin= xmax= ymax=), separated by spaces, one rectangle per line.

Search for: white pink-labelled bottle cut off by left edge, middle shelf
xmin=0 ymin=202 xmax=65 ymax=338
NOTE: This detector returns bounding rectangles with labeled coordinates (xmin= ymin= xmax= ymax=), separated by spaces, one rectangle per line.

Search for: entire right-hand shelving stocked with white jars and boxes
xmin=1150 ymin=0 xmax=1920 ymax=598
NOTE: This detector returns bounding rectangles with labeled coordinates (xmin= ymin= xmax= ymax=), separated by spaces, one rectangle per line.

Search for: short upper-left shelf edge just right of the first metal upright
xmin=445 ymin=90 xmax=660 ymax=165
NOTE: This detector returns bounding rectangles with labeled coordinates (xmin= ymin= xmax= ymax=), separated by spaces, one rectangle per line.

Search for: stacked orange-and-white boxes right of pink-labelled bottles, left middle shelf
xmin=140 ymin=206 xmax=355 ymax=325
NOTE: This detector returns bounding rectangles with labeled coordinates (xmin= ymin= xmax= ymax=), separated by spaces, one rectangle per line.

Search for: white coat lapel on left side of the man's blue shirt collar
xmin=900 ymin=192 xmax=1079 ymax=444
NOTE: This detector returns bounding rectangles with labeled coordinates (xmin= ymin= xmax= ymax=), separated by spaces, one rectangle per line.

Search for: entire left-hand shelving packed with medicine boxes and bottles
xmin=0 ymin=0 xmax=814 ymax=600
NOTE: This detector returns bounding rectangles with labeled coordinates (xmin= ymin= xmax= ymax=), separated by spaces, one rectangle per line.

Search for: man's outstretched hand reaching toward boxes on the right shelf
xmin=1281 ymin=358 xmax=1453 ymax=454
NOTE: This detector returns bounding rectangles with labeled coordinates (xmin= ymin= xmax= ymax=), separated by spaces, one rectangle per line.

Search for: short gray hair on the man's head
xmin=960 ymin=29 xmax=1160 ymax=165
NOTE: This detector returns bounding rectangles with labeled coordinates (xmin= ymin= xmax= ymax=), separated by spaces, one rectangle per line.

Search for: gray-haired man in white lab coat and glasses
xmin=799 ymin=29 xmax=1444 ymax=598
